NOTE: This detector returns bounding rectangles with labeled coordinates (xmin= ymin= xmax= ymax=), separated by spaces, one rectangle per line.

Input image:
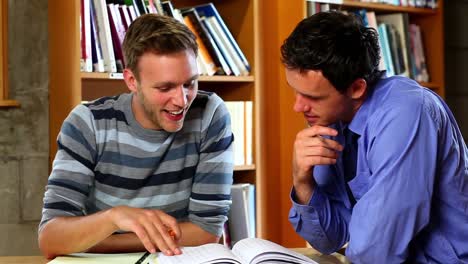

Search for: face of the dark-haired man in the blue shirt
xmin=286 ymin=69 xmax=354 ymax=126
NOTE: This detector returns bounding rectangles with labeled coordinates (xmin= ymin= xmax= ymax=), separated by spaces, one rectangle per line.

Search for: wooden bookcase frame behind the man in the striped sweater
xmin=49 ymin=0 xmax=264 ymax=239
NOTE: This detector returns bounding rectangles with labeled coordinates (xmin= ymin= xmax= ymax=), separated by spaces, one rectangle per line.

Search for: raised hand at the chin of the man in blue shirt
xmin=293 ymin=125 xmax=343 ymax=204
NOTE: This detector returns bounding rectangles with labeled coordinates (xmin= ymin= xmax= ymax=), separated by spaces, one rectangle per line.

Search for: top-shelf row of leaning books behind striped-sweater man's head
xmin=80 ymin=0 xmax=250 ymax=76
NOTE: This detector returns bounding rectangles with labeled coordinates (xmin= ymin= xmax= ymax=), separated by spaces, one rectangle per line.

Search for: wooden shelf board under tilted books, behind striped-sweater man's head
xmin=81 ymin=72 xmax=255 ymax=82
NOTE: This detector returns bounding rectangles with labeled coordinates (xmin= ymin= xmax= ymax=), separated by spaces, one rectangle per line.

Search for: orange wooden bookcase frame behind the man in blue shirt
xmin=259 ymin=0 xmax=445 ymax=247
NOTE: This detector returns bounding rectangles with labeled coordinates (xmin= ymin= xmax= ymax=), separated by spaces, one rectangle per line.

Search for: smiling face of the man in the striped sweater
xmin=127 ymin=50 xmax=198 ymax=132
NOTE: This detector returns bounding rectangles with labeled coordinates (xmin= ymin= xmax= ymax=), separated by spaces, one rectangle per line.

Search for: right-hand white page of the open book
xmin=232 ymin=238 xmax=317 ymax=264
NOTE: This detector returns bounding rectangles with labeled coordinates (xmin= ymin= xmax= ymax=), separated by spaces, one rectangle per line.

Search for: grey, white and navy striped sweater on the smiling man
xmin=39 ymin=91 xmax=233 ymax=235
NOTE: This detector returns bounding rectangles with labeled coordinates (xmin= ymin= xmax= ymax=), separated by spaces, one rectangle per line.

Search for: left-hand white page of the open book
xmin=153 ymin=243 xmax=241 ymax=264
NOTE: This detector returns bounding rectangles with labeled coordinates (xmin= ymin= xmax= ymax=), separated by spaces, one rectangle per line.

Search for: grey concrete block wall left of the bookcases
xmin=0 ymin=0 xmax=48 ymax=255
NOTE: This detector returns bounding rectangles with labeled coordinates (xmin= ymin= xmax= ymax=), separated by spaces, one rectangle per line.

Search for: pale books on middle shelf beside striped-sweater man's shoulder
xmin=225 ymin=101 xmax=253 ymax=166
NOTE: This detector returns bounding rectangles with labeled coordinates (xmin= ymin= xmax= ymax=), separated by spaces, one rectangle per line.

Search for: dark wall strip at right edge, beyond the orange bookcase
xmin=444 ymin=0 xmax=468 ymax=141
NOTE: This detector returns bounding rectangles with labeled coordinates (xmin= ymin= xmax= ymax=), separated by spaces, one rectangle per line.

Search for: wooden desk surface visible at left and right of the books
xmin=0 ymin=248 xmax=350 ymax=264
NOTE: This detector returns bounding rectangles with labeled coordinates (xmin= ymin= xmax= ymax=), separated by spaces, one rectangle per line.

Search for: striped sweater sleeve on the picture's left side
xmin=39 ymin=105 xmax=96 ymax=230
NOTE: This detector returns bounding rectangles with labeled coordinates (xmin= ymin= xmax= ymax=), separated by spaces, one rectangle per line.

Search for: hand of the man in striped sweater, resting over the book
xmin=110 ymin=206 xmax=182 ymax=256
